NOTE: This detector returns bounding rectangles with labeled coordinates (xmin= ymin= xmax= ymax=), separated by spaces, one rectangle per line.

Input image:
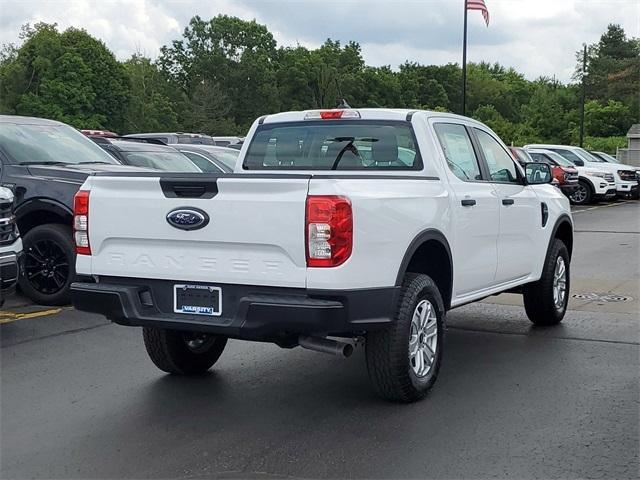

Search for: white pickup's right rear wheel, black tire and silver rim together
xmin=366 ymin=273 xmax=445 ymax=402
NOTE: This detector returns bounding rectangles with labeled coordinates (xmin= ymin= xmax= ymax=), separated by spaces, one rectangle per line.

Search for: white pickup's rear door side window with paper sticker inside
xmin=433 ymin=123 xmax=482 ymax=180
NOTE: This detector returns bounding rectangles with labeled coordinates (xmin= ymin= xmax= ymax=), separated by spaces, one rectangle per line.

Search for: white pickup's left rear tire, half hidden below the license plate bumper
xmin=142 ymin=328 xmax=227 ymax=375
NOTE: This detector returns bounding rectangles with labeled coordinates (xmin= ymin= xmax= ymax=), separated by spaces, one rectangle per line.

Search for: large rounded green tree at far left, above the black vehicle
xmin=0 ymin=23 xmax=129 ymax=130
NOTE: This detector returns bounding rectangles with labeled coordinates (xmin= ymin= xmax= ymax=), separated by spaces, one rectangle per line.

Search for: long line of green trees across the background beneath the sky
xmin=0 ymin=15 xmax=640 ymax=144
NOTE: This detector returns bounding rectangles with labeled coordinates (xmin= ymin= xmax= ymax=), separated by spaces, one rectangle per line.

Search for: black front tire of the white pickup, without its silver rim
xmin=523 ymin=239 xmax=571 ymax=326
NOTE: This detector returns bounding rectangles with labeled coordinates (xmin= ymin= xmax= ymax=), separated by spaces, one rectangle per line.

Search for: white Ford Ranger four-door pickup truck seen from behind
xmin=72 ymin=109 xmax=573 ymax=401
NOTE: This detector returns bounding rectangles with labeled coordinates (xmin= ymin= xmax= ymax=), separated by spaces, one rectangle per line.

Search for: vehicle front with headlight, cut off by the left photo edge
xmin=0 ymin=187 xmax=22 ymax=307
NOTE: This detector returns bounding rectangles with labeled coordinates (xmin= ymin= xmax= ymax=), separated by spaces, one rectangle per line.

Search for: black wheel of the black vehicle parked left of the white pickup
xmin=19 ymin=223 xmax=76 ymax=305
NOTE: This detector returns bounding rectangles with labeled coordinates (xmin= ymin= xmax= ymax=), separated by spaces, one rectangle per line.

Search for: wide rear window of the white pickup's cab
xmin=243 ymin=120 xmax=422 ymax=170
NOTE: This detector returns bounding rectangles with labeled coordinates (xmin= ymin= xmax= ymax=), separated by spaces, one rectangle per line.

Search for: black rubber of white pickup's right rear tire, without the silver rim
xmin=366 ymin=273 xmax=445 ymax=402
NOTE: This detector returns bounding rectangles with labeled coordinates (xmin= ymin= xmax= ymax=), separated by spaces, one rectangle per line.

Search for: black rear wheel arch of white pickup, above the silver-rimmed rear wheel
xmin=396 ymin=228 xmax=453 ymax=310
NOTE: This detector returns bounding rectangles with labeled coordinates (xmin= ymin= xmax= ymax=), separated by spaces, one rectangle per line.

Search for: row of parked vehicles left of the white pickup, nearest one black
xmin=0 ymin=115 xmax=239 ymax=305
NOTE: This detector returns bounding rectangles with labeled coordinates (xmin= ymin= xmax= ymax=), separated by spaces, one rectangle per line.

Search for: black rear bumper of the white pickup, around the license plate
xmin=71 ymin=278 xmax=400 ymax=344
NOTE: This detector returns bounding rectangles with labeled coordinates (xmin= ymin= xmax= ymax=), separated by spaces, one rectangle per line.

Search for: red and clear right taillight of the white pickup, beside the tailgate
xmin=306 ymin=195 xmax=353 ymax=267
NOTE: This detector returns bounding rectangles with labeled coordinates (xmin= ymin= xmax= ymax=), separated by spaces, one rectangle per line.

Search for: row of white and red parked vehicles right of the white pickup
xmin=510 ymin=144 xmax=640 ymax=205
